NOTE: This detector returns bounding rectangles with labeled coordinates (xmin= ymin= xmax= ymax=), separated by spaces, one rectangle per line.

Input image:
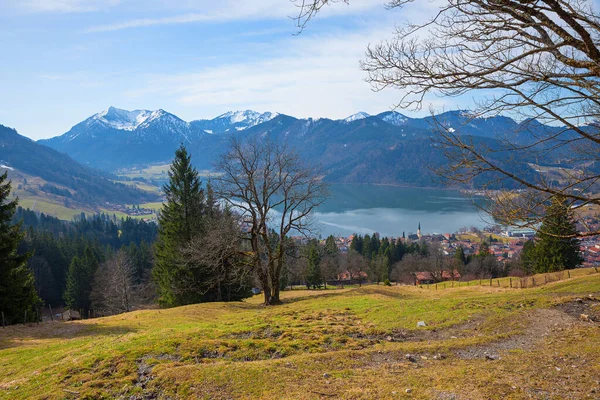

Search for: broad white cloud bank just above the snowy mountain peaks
xmin=120 ymin=22 xmax=454 ymax=119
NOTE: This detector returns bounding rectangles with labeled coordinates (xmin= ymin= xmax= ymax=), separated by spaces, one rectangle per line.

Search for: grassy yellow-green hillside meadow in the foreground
xmin=0 ymin=274 xmax=600 ymax=399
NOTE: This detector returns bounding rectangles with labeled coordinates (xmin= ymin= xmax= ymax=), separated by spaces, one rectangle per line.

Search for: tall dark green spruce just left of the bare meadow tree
xmin=152 ymin=145 xmax=205 ymax=307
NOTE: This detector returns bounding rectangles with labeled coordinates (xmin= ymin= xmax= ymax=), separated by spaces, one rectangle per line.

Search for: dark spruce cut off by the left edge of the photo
xmin=0 ymin=172 xmax=41 ymax=324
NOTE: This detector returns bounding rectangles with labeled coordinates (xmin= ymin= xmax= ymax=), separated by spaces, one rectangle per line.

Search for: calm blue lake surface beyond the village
xmin=315 ymin=185 xmax=491 ymax=237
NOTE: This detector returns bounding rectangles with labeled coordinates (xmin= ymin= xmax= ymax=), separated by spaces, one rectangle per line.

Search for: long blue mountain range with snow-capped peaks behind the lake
xmin=39 ymin=107 xmax=580 ymax=186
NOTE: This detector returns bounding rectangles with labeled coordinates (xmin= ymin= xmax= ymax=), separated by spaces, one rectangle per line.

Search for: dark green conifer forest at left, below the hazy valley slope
xmin=13 ymin=207 xmax=158 ymax=309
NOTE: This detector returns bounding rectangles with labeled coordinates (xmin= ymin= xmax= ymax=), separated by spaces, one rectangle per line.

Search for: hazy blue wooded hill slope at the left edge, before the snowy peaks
xmin=0 ymin=125 xmax=158 ymax=219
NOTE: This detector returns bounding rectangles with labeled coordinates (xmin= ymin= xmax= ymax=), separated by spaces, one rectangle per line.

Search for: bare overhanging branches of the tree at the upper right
xmin=297 ymin=0 xmax=600 ymax=236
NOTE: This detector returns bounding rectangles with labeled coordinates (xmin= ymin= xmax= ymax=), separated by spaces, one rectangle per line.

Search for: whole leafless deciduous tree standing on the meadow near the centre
xmin=216 ymin=138 xmax=327 ymax=305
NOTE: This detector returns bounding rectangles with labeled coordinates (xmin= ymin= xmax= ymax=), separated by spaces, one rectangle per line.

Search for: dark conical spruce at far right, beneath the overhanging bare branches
xmin=534 ymin=196 xmax=583 ymax=273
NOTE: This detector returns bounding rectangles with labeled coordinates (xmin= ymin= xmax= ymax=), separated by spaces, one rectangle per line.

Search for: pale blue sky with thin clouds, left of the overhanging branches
xmin=0 ymin=0 xmax=468 ymax=140
